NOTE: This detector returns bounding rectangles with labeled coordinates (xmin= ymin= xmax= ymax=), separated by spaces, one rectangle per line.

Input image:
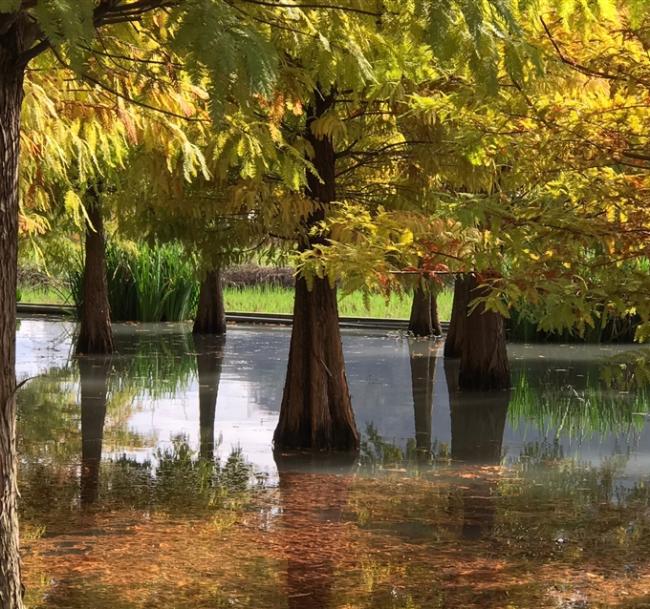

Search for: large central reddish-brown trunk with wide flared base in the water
xmin=273 ymin=91 xmax=359 ymax=451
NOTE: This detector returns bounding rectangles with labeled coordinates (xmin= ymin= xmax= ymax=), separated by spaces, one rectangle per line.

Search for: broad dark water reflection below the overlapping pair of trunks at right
xmin=444 ymin=360 xmax=510 ymax=539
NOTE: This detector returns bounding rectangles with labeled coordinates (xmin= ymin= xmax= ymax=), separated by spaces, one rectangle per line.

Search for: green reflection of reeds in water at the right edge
xmin=508 ymin=370 xmax=650 ymax=437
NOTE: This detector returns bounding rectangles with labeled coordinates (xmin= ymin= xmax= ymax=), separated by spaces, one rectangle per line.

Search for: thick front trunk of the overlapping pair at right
xmin=458 ymin=275 xmax=510 ymax=390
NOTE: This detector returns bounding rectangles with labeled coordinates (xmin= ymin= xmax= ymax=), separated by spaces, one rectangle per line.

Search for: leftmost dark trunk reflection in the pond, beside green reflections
xmin=78 ymin=357 xmax=111 ymax=505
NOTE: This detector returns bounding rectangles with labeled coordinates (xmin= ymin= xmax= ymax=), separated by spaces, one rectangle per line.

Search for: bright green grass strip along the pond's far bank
xmin=15 ymin=286 xmax=453 ymax=320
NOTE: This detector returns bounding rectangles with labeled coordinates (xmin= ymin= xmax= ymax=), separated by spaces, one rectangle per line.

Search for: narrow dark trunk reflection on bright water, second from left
xmin=194 ymin=334 xmax=225 ymax=461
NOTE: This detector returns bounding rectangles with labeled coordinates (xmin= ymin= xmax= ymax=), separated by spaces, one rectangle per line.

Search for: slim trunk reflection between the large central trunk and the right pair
xmin=409 ymin=341 xmax=437 ymax=461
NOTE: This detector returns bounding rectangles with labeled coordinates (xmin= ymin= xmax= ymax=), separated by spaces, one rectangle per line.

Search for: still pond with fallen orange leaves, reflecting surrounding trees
xmin=17 ymin=319 xmax=650 ymax=609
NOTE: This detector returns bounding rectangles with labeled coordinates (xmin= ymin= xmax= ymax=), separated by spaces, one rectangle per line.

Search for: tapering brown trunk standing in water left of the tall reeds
xmin=76 ymin=188 xmax=113 ymax=354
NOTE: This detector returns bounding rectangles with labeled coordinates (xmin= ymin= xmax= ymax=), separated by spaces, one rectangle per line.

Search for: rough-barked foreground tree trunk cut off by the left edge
xmin=0 ymin=36 xmax=24 ymax=609
